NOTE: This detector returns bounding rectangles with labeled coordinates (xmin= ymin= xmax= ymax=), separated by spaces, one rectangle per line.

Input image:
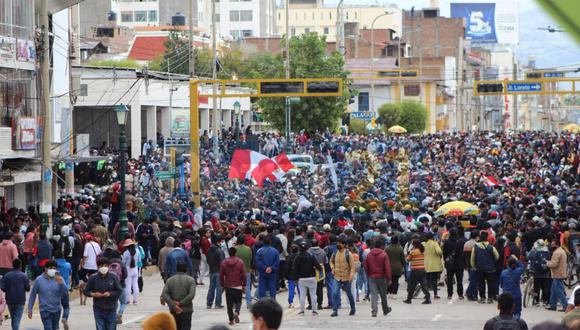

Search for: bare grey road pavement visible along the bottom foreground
xmin=21 ymin=274 xmax=563 ymax=330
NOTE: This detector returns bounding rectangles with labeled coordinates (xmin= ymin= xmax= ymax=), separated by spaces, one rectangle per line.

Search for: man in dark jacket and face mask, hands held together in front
xmin=84 ymin=258 xmax=123 ymax=330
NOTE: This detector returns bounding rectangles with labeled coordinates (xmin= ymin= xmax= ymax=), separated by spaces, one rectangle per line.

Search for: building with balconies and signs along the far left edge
xmin=0 ymin=0 xmax=41 ymax=212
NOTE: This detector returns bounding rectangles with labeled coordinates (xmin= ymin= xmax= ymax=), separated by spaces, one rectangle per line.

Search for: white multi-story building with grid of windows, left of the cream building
xmin=198 ymin=0 xmax=277 ymax=40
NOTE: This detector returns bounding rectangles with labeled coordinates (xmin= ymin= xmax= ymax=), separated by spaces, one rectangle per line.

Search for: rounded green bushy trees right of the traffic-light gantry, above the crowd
xmin=379 ymin=101 xmax=427 ymax=133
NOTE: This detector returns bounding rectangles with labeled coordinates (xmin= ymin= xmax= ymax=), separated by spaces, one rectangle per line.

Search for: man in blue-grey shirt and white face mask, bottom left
xmin=28 ymin=260 xmax=69 ymax=330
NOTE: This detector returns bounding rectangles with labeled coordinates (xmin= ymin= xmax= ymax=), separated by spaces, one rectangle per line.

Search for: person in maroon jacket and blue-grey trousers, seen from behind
xmin=364 ymin=239 xmax=392 ymax=317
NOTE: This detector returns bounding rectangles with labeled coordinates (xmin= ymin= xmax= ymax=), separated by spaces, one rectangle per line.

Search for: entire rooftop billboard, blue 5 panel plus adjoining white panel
xmin=451 ymin=1 xmax=519 ymax=45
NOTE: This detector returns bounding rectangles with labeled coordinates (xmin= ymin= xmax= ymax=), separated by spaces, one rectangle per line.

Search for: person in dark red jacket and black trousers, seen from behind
xmin=219 ymin=247 xmax=246 ymax=325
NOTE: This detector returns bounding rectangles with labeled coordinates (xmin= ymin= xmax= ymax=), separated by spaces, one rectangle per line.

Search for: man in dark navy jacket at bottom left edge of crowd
xmin=0 ymin=259 xmax=30 ymax=330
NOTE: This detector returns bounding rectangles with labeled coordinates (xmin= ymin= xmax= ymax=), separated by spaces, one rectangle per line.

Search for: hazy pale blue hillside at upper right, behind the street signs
xmin=517 ymin=8 xmax=580 ymax=68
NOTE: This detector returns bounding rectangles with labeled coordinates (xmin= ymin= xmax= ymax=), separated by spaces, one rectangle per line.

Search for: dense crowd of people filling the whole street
xmin=0 ymin=131 xmax=580 ymax=329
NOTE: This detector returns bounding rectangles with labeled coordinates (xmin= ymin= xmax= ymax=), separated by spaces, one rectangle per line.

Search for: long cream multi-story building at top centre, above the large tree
xmin=276 ymin=0 xmax=401 ymax=42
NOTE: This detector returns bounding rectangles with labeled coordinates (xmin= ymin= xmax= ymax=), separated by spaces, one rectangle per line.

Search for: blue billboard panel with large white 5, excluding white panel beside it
xmin=451 ymin=3 xmax=497 ymax=43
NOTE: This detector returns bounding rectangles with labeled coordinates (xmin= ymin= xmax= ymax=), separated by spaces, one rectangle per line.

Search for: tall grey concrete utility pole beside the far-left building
xmin=39 ymin=0 xmax=52 ymax=236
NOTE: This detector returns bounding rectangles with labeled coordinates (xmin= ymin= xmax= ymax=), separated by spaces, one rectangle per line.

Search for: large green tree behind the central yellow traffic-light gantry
xmin=242 ymin=33 xmax=348 ymax=131
